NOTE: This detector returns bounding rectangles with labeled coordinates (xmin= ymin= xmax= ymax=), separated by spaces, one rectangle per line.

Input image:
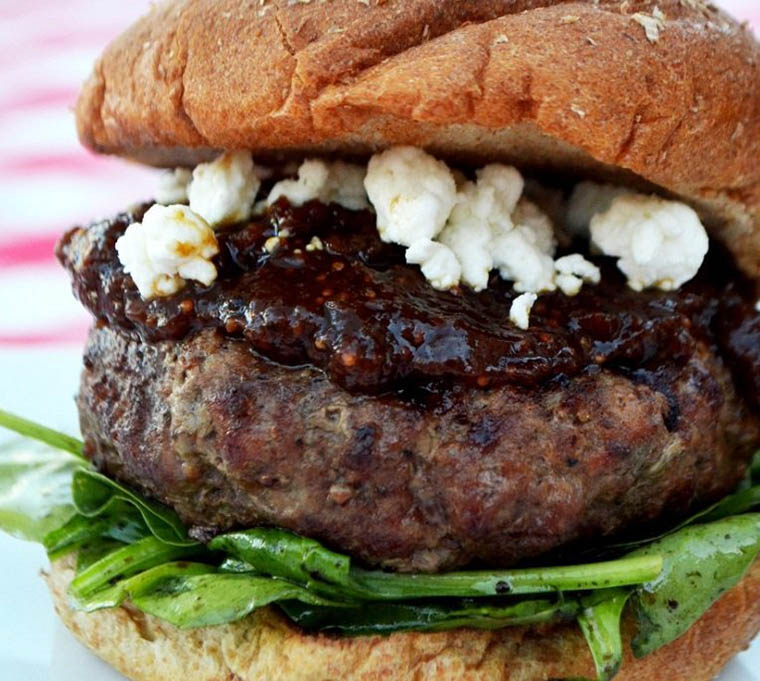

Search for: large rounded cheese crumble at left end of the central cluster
xmin=364 ymin=147 xmax=457 ymax=247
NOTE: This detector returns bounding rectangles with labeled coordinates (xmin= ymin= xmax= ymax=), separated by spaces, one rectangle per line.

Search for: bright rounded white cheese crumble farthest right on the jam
xmin=591 ymin=194 xmax=709 ymax=291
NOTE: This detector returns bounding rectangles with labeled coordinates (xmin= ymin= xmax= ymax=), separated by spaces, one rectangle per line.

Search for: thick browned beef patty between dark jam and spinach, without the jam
xmin=79 ymin=324 xmax=760 ymax=571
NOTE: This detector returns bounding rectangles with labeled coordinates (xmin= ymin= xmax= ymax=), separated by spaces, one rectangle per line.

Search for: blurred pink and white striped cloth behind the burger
xmin=0 ymin=0 xmax=760 ymax=350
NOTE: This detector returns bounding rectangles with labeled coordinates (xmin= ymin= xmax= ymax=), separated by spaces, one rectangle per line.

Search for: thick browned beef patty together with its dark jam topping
xmin=59 ymin=199 xmax=760 ymax=571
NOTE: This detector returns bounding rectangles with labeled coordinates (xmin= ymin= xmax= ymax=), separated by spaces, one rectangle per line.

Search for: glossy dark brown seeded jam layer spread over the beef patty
xmin=59 ymin=201 xmax=760 ymax=399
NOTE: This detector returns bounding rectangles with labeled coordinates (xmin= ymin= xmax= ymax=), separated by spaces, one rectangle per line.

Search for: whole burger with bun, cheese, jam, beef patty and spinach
xmin=0 ymin=0 xmax=760 ymax=681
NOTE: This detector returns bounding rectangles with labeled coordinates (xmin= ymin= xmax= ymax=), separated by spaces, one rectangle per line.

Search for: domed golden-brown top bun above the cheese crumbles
xmin=77 ymin=0 xmax=760 ymax=278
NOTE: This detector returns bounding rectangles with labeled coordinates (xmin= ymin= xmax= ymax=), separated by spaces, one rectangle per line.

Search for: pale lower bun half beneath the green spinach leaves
xmin=47 ymin=558 xmax=760 ymax=681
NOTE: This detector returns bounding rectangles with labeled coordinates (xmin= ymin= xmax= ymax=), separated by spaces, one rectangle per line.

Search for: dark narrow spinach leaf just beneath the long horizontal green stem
xmin=280 ymin=599 xmax=580 ymax=636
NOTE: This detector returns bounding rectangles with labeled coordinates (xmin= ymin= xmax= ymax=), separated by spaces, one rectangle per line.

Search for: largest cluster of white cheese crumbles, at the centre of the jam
xmin=365 ymin=147 xmax=599 ymax=314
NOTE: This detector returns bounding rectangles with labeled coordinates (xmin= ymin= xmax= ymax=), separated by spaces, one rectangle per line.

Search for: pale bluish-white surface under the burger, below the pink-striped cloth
xmin=0 ymin=348 xmax=760 ymax=681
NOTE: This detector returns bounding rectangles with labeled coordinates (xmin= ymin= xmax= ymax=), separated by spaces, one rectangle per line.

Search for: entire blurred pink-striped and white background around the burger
xmin=0 ymin=0 xmax=760 ymax=681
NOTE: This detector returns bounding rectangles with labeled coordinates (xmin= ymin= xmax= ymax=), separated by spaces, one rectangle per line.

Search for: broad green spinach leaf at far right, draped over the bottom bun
xmin=631 ymin=514 xmax=760 ymax=657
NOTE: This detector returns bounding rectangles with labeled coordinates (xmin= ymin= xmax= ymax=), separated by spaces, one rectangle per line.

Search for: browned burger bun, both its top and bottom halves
xmin=55 ymin=0 xmax=760 ymax=681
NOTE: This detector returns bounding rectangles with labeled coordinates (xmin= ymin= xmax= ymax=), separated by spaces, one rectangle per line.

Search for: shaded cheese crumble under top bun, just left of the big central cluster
xmin=267 ymin=160 xmax=369 ymax=210
